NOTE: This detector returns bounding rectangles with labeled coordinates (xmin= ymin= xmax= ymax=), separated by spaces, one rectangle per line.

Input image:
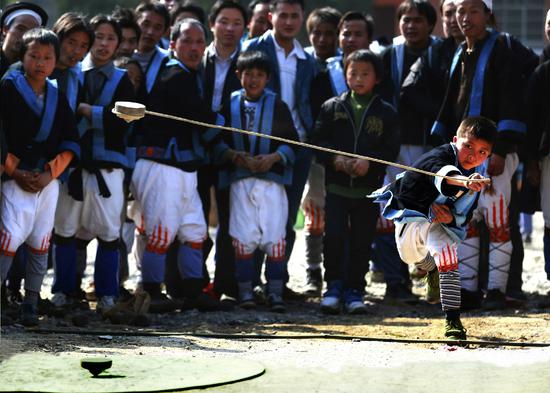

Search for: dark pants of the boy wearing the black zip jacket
xmin=324 ymin=192 xmax=380 ymax=291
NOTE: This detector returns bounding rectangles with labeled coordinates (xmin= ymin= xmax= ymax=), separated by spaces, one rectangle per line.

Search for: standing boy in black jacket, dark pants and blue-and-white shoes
xmin=313 ymin=49 xmax=399 ymax=314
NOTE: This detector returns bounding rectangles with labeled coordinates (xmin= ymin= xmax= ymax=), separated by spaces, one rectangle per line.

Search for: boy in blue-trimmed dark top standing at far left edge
xmin=0 ymin=29 xmax=80 ymax=326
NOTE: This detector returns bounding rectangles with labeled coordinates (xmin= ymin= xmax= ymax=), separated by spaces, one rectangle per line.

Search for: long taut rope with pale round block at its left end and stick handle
xmin=112 ymin=101 xmax=491 ymax=183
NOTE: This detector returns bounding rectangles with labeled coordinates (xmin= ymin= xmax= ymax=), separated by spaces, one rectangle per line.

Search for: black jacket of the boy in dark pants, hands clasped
xmin=311 ymin=92 xmax=399 ymax=188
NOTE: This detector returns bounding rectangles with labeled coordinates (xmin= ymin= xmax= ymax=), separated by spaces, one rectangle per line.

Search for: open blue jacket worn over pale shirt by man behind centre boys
xmin=242 ymin=30 xmax=317 ymax=136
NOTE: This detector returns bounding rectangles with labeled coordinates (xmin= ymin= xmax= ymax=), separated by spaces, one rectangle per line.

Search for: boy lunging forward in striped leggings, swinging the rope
xmin=373 ymin=116 xmax=497 ymax=340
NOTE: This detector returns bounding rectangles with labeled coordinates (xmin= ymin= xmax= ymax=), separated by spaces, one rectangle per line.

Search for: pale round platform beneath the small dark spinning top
xmin=0 ymin=353 xmax=265 ymax=393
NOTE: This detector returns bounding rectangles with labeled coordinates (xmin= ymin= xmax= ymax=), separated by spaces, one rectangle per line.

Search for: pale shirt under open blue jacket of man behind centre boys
xmin=271 ymin=32 xmax=306 ymax=141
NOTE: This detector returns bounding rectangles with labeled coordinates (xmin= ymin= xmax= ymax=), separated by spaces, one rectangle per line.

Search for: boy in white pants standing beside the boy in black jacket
xmin=220 ymin=51 xmax=298 ymax=312
